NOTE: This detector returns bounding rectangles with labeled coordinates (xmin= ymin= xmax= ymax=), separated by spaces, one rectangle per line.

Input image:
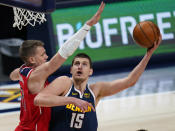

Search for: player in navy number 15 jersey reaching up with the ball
xmin=34 ymin=33 xmax=162 ymax=131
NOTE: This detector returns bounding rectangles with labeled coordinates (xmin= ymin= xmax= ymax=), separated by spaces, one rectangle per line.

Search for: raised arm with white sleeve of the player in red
xmin=28 ymin=2 xmax=105 ymax=92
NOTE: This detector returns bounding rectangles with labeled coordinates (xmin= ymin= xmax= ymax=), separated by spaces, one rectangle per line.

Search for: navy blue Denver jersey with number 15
xmin=49 ymin=85 xmax=98 ymax=131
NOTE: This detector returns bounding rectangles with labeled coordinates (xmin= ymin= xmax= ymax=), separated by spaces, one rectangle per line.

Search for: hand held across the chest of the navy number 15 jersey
xmin=72 ymin=97 xmax=95 ymax=113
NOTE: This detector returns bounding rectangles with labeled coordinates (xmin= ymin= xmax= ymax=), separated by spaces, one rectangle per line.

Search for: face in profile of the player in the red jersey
xmin=29 ymin=46 xmax=48 ymax=67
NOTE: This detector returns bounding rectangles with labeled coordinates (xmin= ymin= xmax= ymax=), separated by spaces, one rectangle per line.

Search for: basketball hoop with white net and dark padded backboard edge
xmin=0 ymin=0 xmax=56 ymax=30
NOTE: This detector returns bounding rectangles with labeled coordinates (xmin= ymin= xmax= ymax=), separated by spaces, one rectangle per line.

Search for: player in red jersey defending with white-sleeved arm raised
xmin=10 ymin=2 xmax=105 ymax=131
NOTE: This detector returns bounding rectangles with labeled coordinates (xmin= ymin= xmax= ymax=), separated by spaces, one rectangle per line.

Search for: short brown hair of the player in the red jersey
xmin=19 ymin=40 xmax=44 ymax=63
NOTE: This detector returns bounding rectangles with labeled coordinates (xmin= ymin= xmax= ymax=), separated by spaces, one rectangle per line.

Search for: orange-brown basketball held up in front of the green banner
xmin=133 ymin=21 xmax=160 ymax=48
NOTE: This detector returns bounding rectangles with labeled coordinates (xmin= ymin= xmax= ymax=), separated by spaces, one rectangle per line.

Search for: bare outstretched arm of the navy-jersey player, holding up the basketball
xmin=96 ymin=36 xmax=162 ymax=97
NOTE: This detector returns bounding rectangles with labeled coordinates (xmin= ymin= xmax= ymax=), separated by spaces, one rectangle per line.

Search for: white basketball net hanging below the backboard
xmin=13 ymin=7 xmax=46 ymax=30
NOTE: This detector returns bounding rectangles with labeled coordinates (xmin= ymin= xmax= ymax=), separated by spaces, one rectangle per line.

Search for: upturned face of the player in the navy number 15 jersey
xmin=71 ymin=58 xmax=93 ymax=81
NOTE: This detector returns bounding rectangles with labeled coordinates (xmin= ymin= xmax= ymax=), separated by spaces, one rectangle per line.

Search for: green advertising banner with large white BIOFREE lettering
xmin=51 ymin=0 xmax=175 ymax=65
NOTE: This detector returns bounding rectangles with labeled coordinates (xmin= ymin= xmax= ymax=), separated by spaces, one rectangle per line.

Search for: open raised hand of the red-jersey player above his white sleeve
xmin=86 ymin=1 xmax=105 ymax=26
